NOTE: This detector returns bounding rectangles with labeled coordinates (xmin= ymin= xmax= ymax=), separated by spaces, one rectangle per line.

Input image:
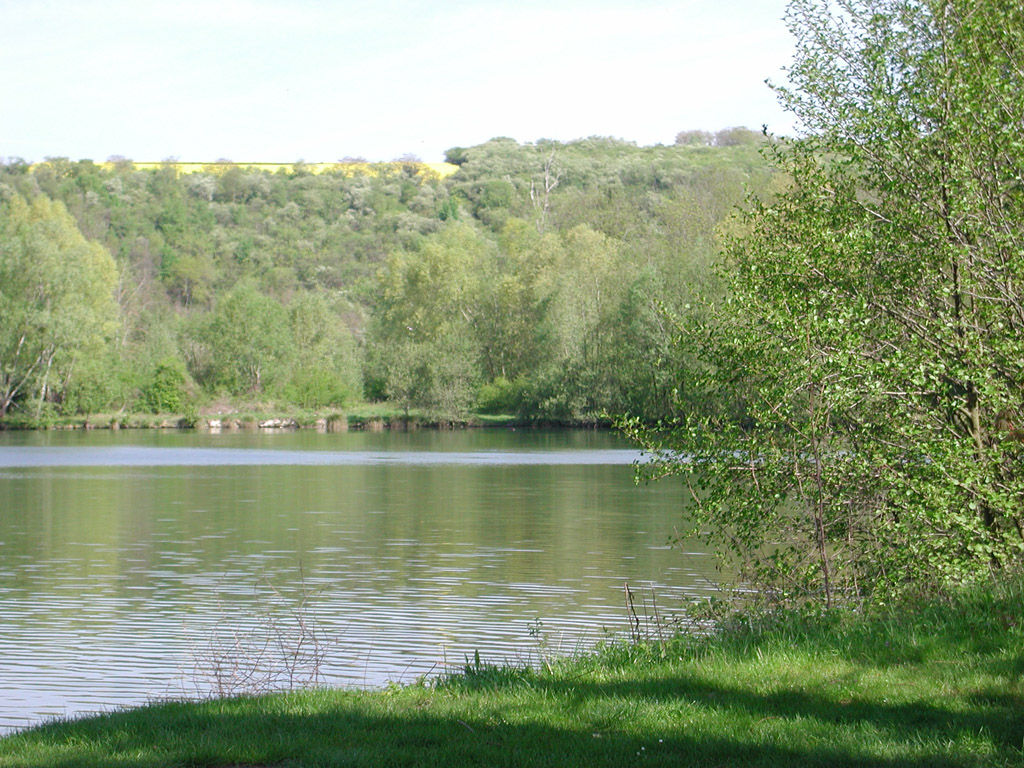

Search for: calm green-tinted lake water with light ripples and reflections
xmin=0 ymin=430 xmax=714 ymax=732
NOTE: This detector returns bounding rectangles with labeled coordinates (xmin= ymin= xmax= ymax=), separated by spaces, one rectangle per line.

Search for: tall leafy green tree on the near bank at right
xmin=633 ymin=0 xmax=1024 ymax=604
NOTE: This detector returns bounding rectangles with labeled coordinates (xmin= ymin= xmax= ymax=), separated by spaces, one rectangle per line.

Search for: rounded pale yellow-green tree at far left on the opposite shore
xmin=0 ymin=196 xmax=118 ymax=417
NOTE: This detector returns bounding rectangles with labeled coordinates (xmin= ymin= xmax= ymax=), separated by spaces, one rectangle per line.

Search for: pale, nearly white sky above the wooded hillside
xmin=0 ymin=0 xmax=794 ymax=163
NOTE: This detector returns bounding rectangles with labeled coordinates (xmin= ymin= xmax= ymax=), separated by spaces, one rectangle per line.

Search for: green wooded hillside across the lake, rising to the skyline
xmin=0 ymin=128 xmax=779 ymax=425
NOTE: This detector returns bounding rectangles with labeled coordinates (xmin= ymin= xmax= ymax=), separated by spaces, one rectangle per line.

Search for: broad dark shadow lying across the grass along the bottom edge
xmin=8 ymin=677 xmax=1024 ymax=768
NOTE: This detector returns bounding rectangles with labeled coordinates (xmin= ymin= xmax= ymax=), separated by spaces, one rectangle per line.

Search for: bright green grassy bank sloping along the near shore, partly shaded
xmin=0 ymin=579 xmax=1024 ymax=768
